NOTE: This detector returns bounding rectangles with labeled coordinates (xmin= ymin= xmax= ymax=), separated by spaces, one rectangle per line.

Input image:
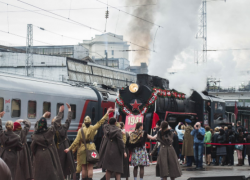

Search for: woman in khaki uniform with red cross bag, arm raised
xmin=64 ymin=108 xmax=114 ymax=180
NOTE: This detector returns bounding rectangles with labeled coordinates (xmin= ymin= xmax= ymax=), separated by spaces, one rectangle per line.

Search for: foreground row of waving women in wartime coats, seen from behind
xmin=0 ymin=104 xmax=184 ymax=180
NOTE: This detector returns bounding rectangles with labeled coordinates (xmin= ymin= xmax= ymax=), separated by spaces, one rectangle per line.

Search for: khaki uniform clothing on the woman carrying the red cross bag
xmin=69 ymin=114 xmax=108 ymax=173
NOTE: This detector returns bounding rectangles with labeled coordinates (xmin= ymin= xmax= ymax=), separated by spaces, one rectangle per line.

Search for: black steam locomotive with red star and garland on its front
xmin=117 ymin=74 xmax=229 ymax=133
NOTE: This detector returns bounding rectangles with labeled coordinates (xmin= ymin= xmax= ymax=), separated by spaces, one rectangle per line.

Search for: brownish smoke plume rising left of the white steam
xmin=126 ymin=0 xmax=157 ymax=65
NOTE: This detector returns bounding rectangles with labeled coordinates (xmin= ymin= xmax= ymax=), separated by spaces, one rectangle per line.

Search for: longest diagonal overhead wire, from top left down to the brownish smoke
xmin=17 ymin=0 xmax=154 ymax=52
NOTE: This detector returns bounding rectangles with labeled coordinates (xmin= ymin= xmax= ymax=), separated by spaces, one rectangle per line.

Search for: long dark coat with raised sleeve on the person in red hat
xmin=14 ymin=120 xmax=34 ymax=180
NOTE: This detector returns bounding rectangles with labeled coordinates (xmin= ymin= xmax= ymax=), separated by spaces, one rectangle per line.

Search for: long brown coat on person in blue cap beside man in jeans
xmin=182 ymin=125 xmax=194 ymax=156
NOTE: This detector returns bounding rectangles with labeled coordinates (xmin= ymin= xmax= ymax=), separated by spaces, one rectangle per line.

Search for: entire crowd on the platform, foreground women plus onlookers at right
xmin=0 ymin=104 xmax=250 ymax=180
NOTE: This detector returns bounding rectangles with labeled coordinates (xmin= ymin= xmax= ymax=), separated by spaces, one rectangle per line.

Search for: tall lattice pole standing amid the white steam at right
xmin=195 ymin=0 xmax=207 ymax=64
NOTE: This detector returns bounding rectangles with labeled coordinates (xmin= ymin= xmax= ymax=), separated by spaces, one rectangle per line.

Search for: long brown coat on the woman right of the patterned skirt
xmin=151 ymin=130 xmax=182 ymax=178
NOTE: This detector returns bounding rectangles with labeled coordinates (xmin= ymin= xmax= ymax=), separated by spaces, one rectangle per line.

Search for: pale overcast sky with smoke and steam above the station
xmin=0 ymin=0 xmax=250 ymax=94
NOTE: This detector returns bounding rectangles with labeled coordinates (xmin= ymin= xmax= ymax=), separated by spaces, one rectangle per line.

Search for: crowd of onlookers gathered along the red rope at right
xmin=175 ymin=119 xmax=250 ymax=170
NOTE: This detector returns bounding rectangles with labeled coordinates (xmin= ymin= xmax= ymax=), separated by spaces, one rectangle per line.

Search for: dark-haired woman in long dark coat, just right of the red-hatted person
xmin=30 ymin=106 xmax=64 ymax=180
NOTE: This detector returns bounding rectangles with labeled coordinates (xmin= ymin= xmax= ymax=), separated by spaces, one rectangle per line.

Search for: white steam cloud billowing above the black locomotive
xmin=149 ymin=0 xmax=250 ymax=95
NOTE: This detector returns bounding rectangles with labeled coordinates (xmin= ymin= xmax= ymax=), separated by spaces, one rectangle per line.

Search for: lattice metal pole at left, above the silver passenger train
xmin=25 ymin=24 xmax=34 ymax=77
